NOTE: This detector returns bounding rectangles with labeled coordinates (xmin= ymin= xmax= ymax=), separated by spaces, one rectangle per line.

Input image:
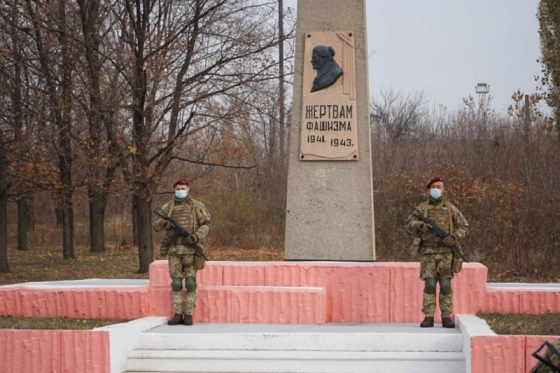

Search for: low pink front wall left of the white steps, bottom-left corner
xmin=0 ymin=329 xmax=110 ymax=373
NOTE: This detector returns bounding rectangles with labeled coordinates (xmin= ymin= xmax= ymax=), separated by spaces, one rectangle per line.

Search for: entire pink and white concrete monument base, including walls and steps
xmin=0 ymin=261 xmax=560 ymax=373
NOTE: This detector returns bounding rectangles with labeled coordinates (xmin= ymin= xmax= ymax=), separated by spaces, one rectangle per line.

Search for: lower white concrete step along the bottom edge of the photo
xmin=127 ymin=350 xmax=466 ymax=373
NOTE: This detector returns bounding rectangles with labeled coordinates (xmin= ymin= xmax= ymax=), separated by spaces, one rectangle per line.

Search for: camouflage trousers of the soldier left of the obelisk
xmin=167 ymin=254 xmax=198 ymax=315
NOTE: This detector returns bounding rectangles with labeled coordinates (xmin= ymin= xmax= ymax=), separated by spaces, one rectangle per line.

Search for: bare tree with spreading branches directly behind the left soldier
xmin=101 ymin=0 xmax=294 ymax=272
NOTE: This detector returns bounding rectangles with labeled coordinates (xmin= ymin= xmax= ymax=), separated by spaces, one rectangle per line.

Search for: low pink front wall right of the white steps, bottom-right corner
xmin=471 ymin=335 xmax=560 ymax=373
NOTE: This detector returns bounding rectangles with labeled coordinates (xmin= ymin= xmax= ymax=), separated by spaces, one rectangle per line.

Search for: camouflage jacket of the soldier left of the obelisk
xmin=153 ymin=196 xmax=212 ymax=254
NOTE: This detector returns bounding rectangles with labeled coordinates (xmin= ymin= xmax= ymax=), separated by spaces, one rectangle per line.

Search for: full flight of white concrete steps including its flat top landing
xmin=126 ymin=324 xmax=466 ymax=373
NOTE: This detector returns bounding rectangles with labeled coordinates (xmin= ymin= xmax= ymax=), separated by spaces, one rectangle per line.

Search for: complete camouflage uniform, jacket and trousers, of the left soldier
xmin=153 ymin=196 xmax=212 ymax=315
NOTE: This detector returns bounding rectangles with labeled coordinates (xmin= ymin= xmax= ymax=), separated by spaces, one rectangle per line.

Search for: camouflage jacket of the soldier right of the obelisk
xmin=404 ymin=198 xmax=470 ymax=254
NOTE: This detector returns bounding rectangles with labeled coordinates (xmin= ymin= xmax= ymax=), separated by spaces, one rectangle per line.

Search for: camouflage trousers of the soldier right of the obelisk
xmin=420 ymin=251 xmax=453 ymax=317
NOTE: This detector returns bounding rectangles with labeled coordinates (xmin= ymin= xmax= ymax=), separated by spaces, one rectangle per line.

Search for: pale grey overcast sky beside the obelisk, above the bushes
xmin=284 ymin=0 xmax=541 ymax=112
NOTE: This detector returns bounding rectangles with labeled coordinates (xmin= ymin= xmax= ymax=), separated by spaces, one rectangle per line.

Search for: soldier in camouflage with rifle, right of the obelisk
xmin=405 ymin=177 xmax=470 ymax=328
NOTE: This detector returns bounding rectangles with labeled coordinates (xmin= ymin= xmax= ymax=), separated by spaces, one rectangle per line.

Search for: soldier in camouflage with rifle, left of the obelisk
xmin=154 ymin=180 xmax=212 ymax=325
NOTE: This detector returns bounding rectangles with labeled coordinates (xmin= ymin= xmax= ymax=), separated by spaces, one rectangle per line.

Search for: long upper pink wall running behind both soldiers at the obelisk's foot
xmin=0 ymin=260 xmax=560 ymax=323
